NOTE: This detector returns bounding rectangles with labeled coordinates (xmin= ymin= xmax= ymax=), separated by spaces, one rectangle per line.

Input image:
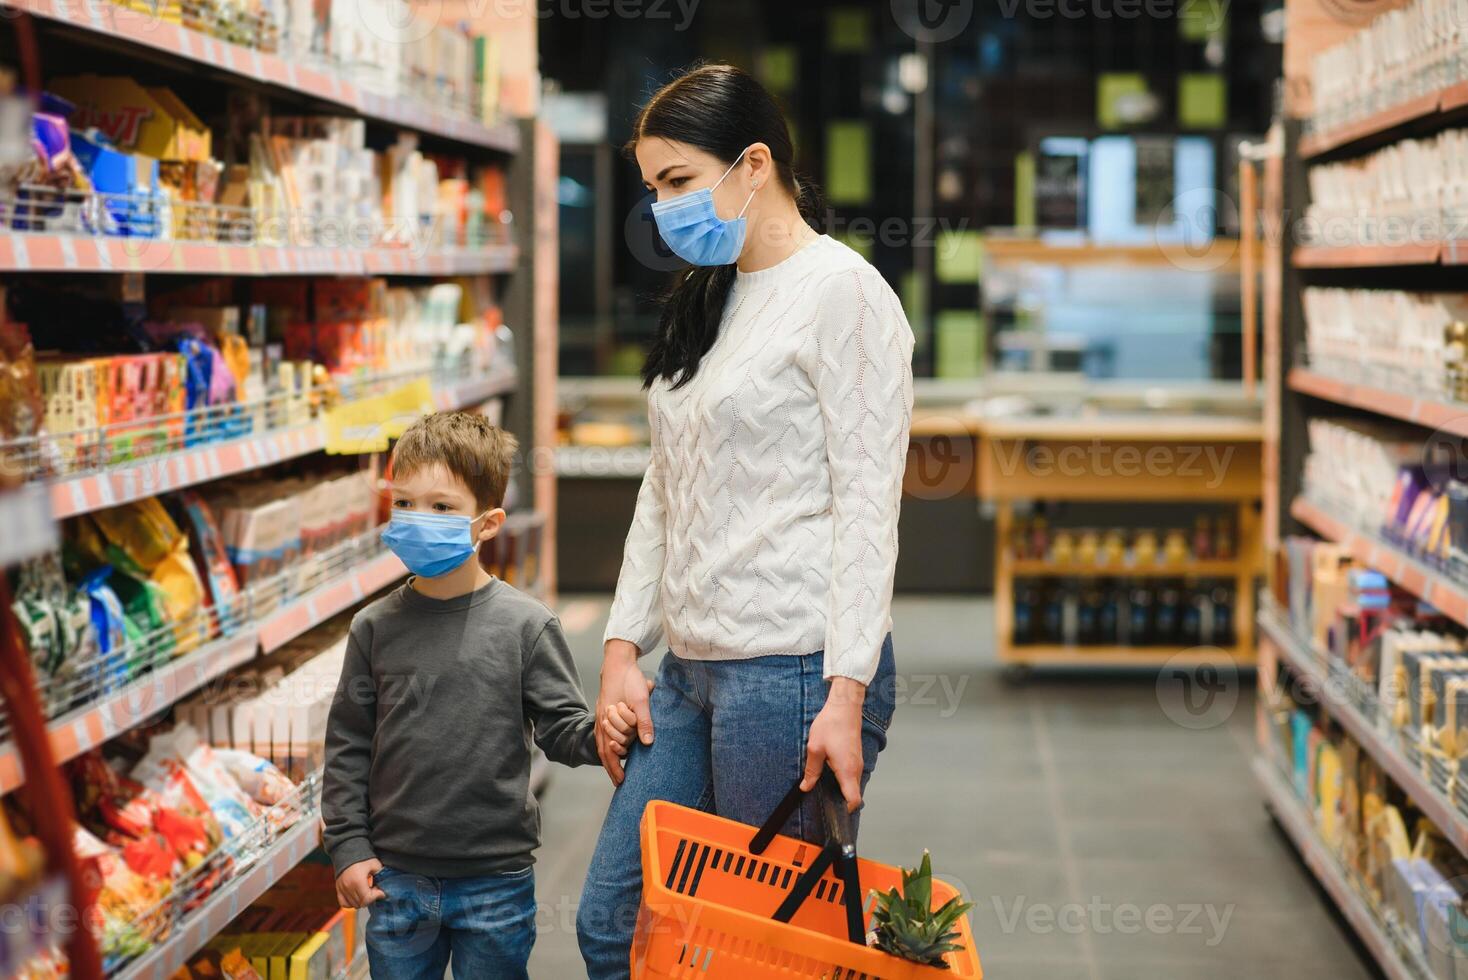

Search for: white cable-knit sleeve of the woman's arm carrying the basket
xmin=807 ymin=267 xmax=913 ymax=684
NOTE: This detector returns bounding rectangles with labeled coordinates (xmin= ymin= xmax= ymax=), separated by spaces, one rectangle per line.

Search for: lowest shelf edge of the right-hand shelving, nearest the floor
xmin=1254 ymin=756 xmax=1433 ymax=980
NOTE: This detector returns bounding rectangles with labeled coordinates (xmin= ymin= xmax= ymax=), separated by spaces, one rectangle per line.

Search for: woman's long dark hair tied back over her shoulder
xmin=625 ymin=65 xmax=816 ymax=387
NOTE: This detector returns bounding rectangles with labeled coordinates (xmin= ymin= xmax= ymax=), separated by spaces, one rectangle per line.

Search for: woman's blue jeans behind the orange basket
xmin=575 ymin=635 xmax=895 ymax=980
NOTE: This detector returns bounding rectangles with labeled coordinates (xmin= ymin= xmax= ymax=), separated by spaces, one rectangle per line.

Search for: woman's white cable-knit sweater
xmin=606 ymin=236 xmax=913 ymax=684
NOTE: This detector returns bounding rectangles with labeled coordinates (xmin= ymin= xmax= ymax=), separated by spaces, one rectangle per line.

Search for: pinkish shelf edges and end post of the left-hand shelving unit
xmin=0 ymin=0 xmax=558 ymax=980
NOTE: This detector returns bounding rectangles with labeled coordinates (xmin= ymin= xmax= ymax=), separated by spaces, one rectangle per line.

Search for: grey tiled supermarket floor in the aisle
xmin=530 ymin=597 xmax=1374 ymax=980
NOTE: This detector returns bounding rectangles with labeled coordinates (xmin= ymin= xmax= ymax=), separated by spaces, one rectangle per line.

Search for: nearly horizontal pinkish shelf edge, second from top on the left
xmin=0 ymin=237 xmax=520 ymax=276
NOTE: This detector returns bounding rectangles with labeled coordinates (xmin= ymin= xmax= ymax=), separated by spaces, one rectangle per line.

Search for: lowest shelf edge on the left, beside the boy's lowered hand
xmin=113 ymin=814 xmax=321 ymax=980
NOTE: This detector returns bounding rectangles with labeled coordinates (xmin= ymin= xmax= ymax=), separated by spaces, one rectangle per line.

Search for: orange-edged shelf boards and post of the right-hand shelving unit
xmin=1254 ymin=0 xmax=1468 ymax=980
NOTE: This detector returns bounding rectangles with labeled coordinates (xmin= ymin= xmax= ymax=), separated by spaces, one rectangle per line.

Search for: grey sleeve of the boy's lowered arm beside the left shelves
xmin=321 ymin=629 xmax=377 ymax=874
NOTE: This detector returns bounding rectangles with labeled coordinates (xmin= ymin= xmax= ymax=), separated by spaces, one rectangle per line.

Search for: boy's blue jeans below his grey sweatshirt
xmin=367 ymin=867 xmax=536 ymax=980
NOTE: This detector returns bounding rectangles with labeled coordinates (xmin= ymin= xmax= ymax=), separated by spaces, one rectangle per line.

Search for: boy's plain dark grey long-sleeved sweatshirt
xmin=321 ymin=579 xmax=599 ymax=877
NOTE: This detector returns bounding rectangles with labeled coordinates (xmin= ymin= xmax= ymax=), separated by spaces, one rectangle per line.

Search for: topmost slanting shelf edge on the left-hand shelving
xmin=0 ymin=0 xmax=520 ymax=153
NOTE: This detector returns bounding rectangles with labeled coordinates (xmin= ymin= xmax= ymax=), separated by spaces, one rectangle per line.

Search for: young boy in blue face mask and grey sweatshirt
xmin=321 ymin=412 xmax=630 ymax=980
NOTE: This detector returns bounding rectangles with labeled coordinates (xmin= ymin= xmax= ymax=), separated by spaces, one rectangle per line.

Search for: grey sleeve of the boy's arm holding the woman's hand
xmin=520 ymin=619 xmax=600 ymax=766
